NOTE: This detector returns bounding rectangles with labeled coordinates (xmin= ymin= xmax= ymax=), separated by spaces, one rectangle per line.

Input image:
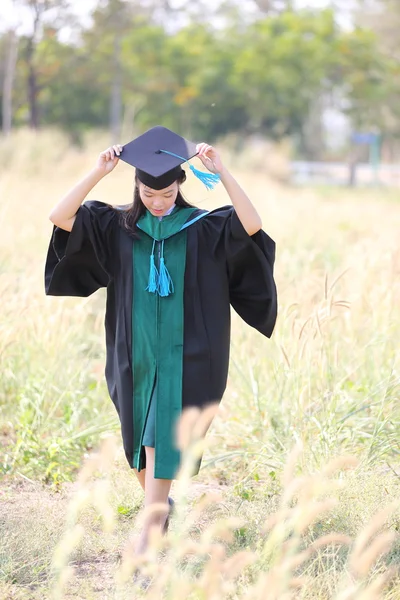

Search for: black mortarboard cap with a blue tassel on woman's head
xmin=120 ymin=125 xmax=219 ymax=190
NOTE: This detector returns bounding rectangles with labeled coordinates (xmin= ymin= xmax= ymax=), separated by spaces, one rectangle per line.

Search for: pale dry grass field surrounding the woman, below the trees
xmin=0 ymin=132 xmax=400 ymax=600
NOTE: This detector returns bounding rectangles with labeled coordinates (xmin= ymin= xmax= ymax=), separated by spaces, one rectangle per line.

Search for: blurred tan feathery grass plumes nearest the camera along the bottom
xmin=36 ymin=428 xmax=399 ymax=600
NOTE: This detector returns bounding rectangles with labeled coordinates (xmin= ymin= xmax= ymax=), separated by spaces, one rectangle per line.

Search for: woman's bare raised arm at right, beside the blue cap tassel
xmin=197 ymin=143 xmax=262 ymax=235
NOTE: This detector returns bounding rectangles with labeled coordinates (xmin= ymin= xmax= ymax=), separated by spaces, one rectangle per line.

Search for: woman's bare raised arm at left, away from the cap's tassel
xmin=49 ymin=145 xmax=122 ymax=231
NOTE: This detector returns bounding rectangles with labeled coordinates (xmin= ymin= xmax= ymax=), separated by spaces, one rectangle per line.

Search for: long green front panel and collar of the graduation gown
xmin=132 ymin=207 xmax=206 ymax=478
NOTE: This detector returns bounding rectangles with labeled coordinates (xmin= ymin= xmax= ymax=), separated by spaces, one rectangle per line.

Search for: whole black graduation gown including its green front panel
xmin=44 ymin=201 xmax=277 ymax=479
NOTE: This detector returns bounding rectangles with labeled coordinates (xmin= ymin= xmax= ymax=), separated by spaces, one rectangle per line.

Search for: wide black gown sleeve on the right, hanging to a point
xmin=208 ymin=206 xmax=277 ymax=337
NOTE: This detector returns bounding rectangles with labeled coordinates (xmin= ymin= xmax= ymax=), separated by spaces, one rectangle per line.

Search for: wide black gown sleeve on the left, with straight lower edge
xmin=44 ymin=200 xmax=116 ymax=297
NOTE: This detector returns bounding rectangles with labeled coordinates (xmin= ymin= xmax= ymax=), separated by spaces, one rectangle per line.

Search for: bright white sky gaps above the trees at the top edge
xmin=0 ymin=0 xmax=353 ymax=32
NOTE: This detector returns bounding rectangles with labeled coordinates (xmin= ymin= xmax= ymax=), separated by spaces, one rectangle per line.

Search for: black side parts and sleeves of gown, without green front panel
xmin=45 ymin=201 xmax=277 ymax=475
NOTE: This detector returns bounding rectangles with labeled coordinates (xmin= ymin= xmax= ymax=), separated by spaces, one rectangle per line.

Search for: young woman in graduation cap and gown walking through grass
xmin=45 ymin=128 xmax=277 ymax=552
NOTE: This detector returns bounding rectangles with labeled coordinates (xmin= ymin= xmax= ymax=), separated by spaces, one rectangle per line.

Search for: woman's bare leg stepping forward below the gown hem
xmin=136 ymin=446 xmax=172 ymax=553
